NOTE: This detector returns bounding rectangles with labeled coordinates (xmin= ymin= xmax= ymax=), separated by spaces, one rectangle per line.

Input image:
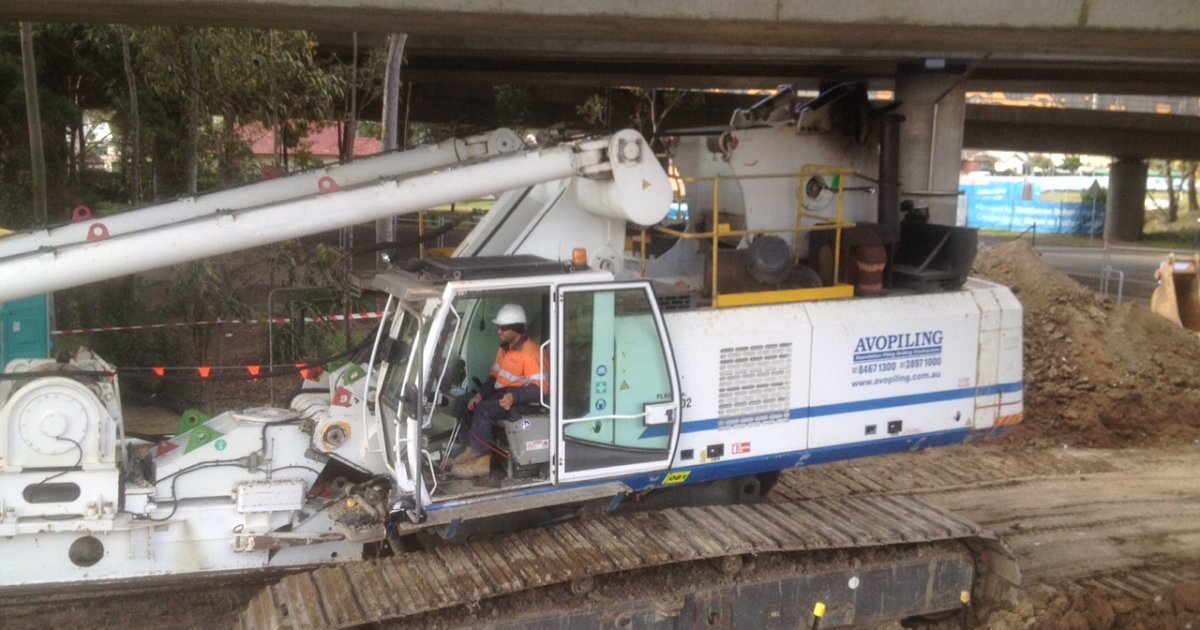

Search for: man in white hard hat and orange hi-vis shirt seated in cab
xmin=450 ymin=304 xmax=548 ymax=479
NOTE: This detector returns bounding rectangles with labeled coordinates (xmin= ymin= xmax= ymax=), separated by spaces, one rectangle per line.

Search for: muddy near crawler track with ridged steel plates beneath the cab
xmin=240 ymin=496 xmax=1016 ymax=630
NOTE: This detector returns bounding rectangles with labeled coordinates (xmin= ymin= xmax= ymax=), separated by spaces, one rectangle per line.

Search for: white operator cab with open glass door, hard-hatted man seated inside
xmin=373 ymin=256 xmax=680 ymax=509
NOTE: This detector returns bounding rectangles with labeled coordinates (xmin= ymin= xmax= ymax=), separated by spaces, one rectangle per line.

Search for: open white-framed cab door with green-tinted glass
xmin=551 ymin=282 xmax=680 ymax=482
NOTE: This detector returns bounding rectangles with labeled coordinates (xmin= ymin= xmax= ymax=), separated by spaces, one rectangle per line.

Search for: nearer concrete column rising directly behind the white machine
xmin=895 ymin=70 xmax=966 ymax=226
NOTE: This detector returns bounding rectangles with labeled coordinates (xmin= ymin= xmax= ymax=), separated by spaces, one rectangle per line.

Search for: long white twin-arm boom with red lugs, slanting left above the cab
xmin=0 ymin=130 xmax=671 ymax=302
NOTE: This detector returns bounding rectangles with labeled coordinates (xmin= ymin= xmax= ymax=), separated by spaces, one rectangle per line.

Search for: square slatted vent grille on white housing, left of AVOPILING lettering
xmin=718 ymin=343 xmax=792 ymax=428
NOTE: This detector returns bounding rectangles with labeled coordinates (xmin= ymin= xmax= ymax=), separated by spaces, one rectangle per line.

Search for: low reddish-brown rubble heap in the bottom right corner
xmin=982 ymin=582 xmax=1200 ymax=630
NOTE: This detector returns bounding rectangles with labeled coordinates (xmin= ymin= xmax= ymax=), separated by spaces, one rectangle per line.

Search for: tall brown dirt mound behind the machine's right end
xmin=973 ymin=241 xmax=1200 ymax=448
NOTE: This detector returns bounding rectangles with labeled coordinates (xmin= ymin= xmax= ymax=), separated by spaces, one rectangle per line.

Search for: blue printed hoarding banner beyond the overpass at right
xmin=959 ymin=179 xmax=1105 ymax=236
